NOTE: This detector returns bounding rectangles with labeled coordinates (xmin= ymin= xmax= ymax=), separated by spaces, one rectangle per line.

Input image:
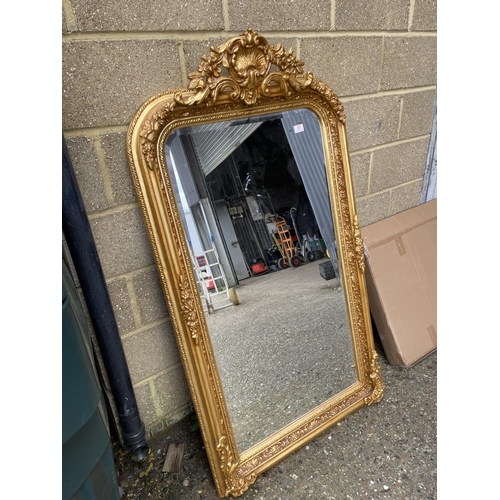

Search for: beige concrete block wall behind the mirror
xmin=62 ymin=0 xmax=437 ymax=433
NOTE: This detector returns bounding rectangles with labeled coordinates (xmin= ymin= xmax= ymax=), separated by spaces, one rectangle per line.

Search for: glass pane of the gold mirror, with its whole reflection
xmin=165 ymin=108 xmax=357 ymax=454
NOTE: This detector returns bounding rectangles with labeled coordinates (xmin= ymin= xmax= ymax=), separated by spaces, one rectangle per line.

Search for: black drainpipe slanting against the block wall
xmin=62 ymin=136 xmax=149 ymax=461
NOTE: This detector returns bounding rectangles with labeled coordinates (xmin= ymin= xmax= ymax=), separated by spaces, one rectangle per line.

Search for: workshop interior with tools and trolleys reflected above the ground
xmin=165 ymin=109 xmax=340 ymax=313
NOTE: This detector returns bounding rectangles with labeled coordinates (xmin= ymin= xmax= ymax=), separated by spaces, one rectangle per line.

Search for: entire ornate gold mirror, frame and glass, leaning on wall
xmin=127 ymin=29 xmax=384 ymax=497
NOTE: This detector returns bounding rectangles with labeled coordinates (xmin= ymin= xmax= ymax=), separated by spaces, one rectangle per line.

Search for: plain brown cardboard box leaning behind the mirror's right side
xmin=361 ymin=200 xmax=437 ymax=366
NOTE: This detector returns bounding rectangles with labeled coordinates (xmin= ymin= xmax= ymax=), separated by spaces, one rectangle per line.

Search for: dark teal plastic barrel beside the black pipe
xmin=62 ymin=261 xmax=120 ymax=500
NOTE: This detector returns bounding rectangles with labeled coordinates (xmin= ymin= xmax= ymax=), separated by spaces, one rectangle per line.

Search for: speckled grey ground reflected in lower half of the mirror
xmin=207 ymin=259 xmax=356 ymax=453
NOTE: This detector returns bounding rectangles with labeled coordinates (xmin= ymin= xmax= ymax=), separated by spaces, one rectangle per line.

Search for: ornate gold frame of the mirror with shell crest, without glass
xmin=127 ymin=30 xmax=384 ymax=497
